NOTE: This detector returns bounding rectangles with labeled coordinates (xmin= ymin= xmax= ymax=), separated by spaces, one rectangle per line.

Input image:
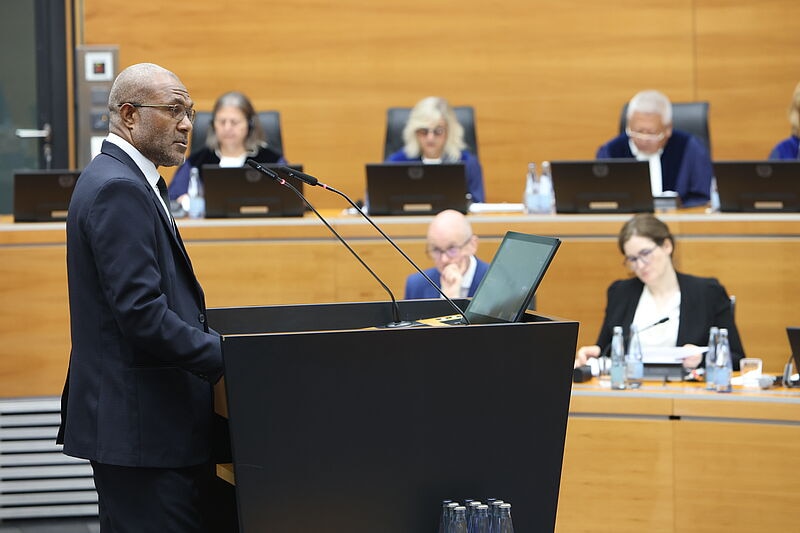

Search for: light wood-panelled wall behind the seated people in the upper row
xmin=76 ymin=0 xmax=800 ymax=207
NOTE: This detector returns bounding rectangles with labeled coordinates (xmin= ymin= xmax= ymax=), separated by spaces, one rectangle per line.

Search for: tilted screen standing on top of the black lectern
xmin=418 ymin=231 xmax=561 ymax=326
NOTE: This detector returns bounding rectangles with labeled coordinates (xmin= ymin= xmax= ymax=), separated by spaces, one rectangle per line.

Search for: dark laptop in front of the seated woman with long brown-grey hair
xmin=200 ymin=163 xmax=305 ymax=218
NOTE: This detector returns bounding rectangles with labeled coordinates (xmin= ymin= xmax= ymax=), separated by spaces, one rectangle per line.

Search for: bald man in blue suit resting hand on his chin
xmin=405 ymin=209 xmax=489 ymax=300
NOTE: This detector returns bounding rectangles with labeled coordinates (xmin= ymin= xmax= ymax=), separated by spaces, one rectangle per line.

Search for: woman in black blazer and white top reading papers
xmin=575 ymin=214 xmax=744 ymax=370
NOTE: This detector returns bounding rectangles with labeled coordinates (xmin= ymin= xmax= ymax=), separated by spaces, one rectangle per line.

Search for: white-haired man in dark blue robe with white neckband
xmin=597 ymin=90 xmax=713 ymax=207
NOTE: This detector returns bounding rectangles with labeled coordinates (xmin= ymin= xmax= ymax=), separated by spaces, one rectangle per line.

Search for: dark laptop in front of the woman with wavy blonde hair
xmin=366 ymin=163 xmax=469 ymax=215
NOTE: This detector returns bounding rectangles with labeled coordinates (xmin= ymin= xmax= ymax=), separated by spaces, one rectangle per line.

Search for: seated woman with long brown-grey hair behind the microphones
xmin=169 ymin=91 xmax=286 ymax=207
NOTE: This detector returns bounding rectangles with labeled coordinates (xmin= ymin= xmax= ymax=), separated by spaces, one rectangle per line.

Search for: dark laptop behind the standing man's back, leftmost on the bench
xmin=14 ymin=170 xmax=81 ymax=222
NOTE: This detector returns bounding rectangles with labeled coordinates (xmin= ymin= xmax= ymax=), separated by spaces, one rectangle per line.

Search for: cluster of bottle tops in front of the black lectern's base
xmin=439 ymin=498 xmax=514 ymax=533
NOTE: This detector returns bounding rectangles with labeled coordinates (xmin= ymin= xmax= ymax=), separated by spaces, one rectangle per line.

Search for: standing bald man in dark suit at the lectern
xmin=59 ymin=63 xmax=222 ymax=533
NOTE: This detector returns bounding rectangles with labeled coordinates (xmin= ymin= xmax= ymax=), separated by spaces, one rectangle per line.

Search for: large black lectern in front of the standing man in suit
xmin=209 ymin=300 xmax=578 ymax=533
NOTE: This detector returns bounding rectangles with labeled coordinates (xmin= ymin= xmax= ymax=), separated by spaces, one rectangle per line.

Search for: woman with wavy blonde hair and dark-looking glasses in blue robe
xmin=386 ymin=96 xmax=486 ymax=202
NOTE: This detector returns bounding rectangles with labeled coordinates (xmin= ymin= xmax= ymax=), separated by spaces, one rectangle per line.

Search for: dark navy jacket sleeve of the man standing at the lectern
xmin=83 ymin=178 xmax=222 ymax=382
